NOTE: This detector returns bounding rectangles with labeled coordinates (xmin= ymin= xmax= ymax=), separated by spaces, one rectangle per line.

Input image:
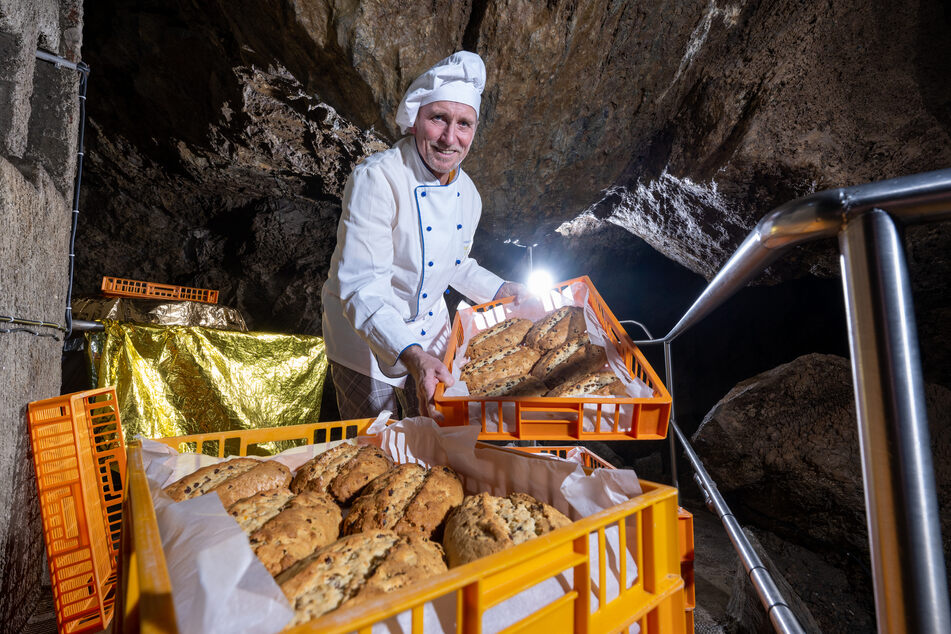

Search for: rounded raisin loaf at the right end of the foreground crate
xmin=443 ymin=493 xmax=571 ymax=567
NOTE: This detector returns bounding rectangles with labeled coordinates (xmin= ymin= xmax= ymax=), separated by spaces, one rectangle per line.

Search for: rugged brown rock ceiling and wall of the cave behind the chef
xmin=77 ymin=0 xmax=951 ymax=332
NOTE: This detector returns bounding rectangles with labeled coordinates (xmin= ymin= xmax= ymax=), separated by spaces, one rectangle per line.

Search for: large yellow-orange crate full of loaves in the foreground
xmin=126 ymin=419 xmax=692 ymax=634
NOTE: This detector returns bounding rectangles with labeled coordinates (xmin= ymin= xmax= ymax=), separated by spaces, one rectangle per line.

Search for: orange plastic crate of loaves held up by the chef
xmin=434 ymin=276 xmax=671 ymax=441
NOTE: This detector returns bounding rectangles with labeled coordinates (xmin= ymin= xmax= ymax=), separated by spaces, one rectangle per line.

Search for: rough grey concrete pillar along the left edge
xmin=0 ymin=0 xmax=82 ymax=632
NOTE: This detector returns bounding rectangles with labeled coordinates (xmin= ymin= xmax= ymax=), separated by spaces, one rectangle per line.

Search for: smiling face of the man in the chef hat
xmin=410 ymin=101 xmax=478 ymax=185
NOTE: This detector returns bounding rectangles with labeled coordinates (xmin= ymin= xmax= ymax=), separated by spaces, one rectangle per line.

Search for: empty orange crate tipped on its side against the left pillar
xmin=27 ymin=387 xmax=126 ymax=632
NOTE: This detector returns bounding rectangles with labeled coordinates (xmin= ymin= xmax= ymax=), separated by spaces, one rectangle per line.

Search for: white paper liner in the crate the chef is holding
xmin=444 ymin=282 xmax=654 ymax=433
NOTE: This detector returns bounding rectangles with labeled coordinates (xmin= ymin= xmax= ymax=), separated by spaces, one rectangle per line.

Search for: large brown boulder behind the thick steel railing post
xmin=693 ymin=354 xmax=951 ymax=624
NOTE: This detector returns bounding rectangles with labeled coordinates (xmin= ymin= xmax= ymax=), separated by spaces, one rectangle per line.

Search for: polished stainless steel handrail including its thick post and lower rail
xmin=635 ymin=169 xmax=951 ymax=632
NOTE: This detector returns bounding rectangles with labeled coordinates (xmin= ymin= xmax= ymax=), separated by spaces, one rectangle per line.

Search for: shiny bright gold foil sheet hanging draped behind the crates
xmin=86 ymin=320 xmax=328 ymax=451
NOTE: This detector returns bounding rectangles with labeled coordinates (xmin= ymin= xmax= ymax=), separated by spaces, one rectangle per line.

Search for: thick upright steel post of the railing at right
xmin=839 ymin=209 xmax=951 ymax=632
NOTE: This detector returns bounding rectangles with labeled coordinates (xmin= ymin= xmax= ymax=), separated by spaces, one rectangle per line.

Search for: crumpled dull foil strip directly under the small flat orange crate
xmin=72 ymin=297 xmax=248 ymax=331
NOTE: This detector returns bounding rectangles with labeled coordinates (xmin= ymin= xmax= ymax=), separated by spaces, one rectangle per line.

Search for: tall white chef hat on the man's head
xmin=396 ymin=51 xmax=485 ymax=134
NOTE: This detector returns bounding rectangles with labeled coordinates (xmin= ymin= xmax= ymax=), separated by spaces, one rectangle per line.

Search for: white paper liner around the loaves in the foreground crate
xmin=140 ymin=412 xmax=641 ymax=633
